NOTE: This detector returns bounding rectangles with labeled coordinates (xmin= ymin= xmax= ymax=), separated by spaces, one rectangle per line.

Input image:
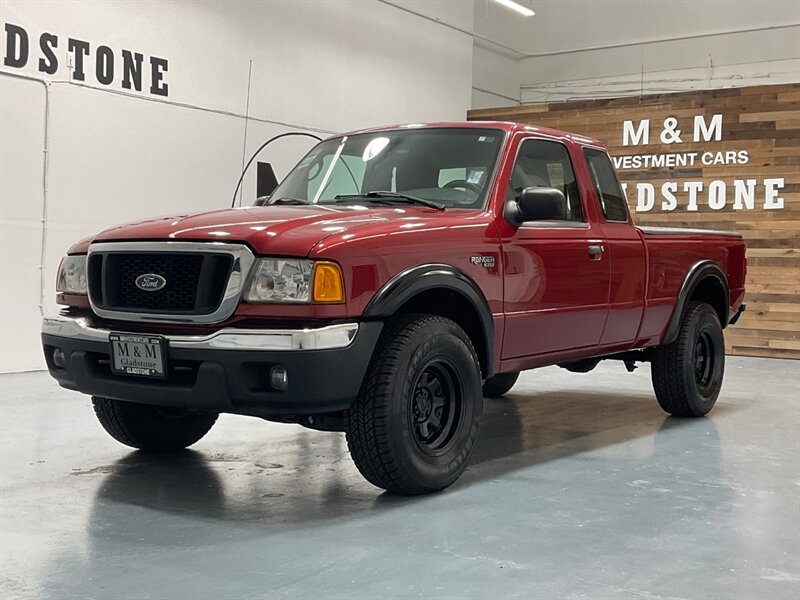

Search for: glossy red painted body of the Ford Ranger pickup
xmin=59 ymin=122 xmax=746 ymax=372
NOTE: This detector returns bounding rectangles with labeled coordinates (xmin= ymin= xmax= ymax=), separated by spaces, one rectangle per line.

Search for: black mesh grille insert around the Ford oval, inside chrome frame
xmin=89 ymin=252 xmax=233 ymax=315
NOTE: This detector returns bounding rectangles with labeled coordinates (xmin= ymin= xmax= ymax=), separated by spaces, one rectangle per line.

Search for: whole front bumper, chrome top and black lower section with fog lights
xmin=42 ymin=315 xmax=383 ymax=417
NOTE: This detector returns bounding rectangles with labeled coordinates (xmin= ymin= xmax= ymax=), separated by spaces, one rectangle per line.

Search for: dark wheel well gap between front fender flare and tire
xmin=397 ymin=288 xmax=491 ymax=377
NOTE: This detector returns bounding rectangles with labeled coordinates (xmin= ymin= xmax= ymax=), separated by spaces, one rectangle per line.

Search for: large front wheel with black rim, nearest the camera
xmin=347 ymin=315 xmax=483 ymax=494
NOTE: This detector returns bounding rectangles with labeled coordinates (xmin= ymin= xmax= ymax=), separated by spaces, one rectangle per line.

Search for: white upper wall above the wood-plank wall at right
xmin=473 ymin=0 xmax=800 ymax=108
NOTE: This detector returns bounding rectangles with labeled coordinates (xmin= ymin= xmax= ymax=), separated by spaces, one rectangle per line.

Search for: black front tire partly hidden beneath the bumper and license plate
xmin=92 ymin=396 xmax=219 ymax=452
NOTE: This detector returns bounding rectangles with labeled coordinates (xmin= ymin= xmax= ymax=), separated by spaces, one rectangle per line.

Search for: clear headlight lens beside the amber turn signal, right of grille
xmin=244 ymin=258 xmax=314 ymax=303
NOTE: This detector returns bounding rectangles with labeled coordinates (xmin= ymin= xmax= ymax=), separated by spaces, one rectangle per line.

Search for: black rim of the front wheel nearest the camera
xmin=408 ymin=358 xmax=464 ymax=456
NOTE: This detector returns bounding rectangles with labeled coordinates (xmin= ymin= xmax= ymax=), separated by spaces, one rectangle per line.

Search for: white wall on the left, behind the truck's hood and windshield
xmin=0 ymin=0 xmax=473 ymax=372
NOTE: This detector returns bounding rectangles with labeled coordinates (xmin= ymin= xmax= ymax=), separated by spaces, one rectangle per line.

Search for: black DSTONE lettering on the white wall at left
xmin=3 ymin=23 xmax=169 ymax=96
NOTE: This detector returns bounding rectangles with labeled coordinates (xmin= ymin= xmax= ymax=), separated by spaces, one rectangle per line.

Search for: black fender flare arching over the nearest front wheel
xmin=364 ymin=263 xmax=494 ymax=378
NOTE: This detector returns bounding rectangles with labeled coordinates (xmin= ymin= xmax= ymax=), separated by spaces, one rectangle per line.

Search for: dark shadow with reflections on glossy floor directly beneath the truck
xmin=84 ymin=392 xmax=733 ymax=532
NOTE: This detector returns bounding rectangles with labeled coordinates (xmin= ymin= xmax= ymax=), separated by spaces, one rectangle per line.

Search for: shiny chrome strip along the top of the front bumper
xmin=42 ymin=315 xmax=358 ymax=351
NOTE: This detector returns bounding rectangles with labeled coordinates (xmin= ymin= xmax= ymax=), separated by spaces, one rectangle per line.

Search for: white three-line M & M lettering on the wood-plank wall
xmin=613 ymin=113 xmax=785 ymax=212
